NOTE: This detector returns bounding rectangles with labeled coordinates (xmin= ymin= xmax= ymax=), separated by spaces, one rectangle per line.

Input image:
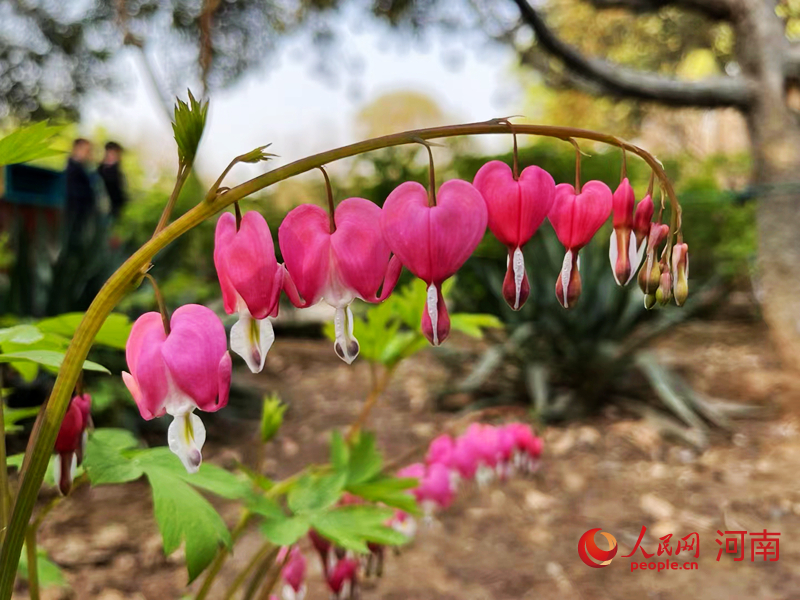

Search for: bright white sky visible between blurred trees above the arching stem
xmin=82 ymin=8 xmax=522 ymax=181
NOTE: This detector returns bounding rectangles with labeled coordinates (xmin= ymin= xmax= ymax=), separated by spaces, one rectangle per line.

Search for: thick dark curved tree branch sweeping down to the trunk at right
xmin=514 ymin=0 xmax=753 ymax=107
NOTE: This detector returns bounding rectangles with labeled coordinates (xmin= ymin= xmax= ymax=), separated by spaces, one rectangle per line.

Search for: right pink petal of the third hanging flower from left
xmin=330 ymin=198 xmax=390 ymax=301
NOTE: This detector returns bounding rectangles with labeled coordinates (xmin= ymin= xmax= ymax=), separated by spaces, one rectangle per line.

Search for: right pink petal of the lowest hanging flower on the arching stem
xmin=161 ymin=304 xmax=230 ymax=411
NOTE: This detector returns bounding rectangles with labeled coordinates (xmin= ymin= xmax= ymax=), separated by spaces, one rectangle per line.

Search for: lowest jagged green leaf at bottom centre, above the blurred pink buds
xmin=311 ymin=504 xmax=408 ymax=553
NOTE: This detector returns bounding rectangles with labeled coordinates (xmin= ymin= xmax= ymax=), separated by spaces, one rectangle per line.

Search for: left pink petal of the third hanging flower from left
xmin=278 ymin=204 xmax=331 ymax=307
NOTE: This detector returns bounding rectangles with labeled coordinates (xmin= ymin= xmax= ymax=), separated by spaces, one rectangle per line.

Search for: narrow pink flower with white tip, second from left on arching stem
xmin=214 ymin=211 xmax=283 ymax=373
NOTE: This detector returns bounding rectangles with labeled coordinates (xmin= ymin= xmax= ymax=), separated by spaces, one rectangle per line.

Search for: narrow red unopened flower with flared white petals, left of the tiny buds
xmin=608 ymin=177 xmax=653 ymax=285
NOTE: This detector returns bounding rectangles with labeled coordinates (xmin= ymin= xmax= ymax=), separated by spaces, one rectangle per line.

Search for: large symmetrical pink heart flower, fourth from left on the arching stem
xmin=381 ymin=179 xmax=488 ymax=346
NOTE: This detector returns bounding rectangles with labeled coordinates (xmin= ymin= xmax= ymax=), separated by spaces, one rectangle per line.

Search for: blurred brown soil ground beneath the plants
xmin=9 ymin=320 xmax=800 ymax=600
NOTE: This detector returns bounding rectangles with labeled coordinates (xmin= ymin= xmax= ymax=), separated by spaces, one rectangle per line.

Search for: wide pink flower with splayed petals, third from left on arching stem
xmin=278 ymin=198 xmax=402 ymax=364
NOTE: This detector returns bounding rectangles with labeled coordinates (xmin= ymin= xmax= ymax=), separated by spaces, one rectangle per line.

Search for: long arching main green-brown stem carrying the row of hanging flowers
xmin=0 ymin=121 xmax=680 ymax=600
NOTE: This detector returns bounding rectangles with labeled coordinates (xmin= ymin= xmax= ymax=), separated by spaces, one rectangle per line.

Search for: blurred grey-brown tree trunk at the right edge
xmin=734 ymin=0 xmax=800 ymax=370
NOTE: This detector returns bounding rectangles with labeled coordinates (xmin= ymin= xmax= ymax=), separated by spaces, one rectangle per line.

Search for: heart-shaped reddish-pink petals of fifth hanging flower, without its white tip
xmin=474 ymin=160 xmax=555 ymax=247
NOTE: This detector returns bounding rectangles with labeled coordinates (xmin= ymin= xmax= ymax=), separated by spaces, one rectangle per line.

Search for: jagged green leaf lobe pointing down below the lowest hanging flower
xmin=147 ymin=469 xmax=231 ymax=583
